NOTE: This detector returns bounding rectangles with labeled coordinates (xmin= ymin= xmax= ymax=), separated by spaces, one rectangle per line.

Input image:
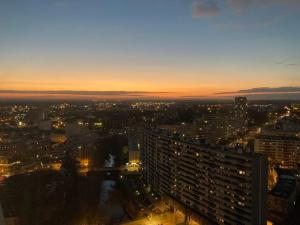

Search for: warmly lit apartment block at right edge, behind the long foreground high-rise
xmin=255 ymin=120 xmax=300 ymax=169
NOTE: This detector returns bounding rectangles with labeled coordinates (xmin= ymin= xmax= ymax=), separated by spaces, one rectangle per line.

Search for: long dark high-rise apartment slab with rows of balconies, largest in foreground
xmin=142 ymin=128 xmax=268 ymax=225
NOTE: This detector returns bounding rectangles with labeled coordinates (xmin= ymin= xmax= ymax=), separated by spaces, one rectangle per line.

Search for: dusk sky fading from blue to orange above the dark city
xmin=0 ymin=0 xmax=300 ymax=99
